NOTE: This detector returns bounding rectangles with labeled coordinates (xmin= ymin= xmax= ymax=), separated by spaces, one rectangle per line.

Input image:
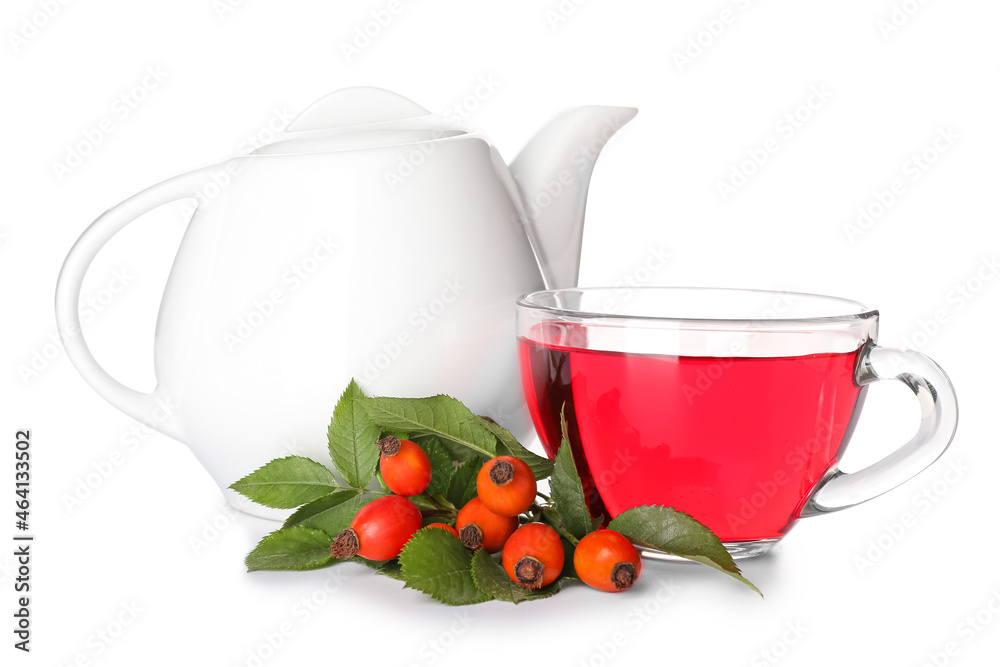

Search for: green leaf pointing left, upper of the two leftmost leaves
xmin=229 ymin=456 xmax=338 ymax=509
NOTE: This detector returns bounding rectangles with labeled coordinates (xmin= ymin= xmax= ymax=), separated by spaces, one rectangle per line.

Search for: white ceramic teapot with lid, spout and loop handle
xmin=56 ymin=88 xmax=636 ymax=513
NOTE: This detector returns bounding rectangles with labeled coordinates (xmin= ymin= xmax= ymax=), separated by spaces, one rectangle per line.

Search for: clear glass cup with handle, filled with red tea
xmin=517 ymin=287 xmax=958 ymax=558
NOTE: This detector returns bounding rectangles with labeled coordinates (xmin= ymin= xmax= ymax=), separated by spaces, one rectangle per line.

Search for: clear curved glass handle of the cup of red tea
xmin=801 ymin=343 xmax=958 ymax=516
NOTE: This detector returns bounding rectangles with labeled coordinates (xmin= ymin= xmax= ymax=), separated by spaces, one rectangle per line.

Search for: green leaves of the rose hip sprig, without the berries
xmin=230 ymin=380 xmax=760 ymax=605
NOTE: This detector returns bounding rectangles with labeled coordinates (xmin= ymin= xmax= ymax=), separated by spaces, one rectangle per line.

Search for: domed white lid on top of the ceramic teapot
xmin=251 ymin=86 xmax=474 ymax=155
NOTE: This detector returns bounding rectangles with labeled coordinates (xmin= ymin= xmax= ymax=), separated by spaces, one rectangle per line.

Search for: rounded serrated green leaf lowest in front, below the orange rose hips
xmin=399 ymin=528 xmax=490 ymax=605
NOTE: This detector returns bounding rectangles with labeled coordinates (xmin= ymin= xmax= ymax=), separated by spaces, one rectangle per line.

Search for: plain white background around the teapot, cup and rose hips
xmin=0 ymin=0 xmax=1000 ymax=666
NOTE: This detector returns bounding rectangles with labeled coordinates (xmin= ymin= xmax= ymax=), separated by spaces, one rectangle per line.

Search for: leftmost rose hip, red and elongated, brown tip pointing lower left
xmin=330 ymin=496 xmax=423 ymax=560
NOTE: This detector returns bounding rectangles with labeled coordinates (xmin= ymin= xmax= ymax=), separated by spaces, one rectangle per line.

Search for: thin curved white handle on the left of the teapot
xmin=56 ymin=167 xmax=213 ymax=437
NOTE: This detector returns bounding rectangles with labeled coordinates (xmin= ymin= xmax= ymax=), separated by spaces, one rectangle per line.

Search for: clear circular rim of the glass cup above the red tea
xmin=516 ymin=286 xmax=879 ymax=328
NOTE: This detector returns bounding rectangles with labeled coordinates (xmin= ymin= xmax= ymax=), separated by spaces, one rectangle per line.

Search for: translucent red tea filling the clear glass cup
xmin=519 ymin=339 xmax=860 ymax=541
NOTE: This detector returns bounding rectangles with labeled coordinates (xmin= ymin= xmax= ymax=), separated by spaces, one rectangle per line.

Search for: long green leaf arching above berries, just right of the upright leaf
xmin=361 ymin=394 xmax=497 ymax=459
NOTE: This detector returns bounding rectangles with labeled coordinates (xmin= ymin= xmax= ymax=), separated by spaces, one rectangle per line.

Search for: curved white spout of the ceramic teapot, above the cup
xmin=510 ymin=106 xmax=638 ymax=289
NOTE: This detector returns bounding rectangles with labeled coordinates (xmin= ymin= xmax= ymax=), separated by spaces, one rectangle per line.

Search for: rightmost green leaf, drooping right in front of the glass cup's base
xmin=608 ymin=505 xmax=763 ymax=595
